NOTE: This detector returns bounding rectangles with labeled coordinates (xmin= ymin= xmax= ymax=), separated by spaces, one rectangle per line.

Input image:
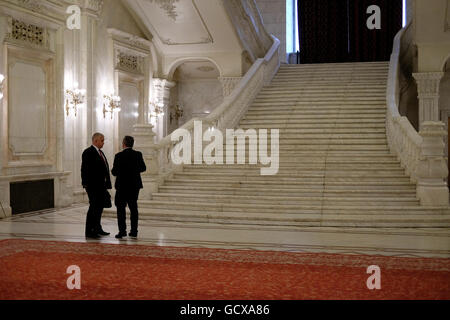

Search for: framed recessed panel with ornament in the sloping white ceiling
xmin=137 ymin=0 xmax=213 ymax=45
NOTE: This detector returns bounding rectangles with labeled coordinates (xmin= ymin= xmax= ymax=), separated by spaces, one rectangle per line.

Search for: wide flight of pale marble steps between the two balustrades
xmin=139 ymin=62 xmax=450 ymax=227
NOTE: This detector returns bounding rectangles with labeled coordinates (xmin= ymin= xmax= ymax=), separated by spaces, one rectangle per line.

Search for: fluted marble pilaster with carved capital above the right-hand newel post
xmin=413 ymin=72 xmax=444 ymax=131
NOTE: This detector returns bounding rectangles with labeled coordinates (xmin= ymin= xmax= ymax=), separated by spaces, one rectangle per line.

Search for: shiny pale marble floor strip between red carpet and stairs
xmin=0 ymin=205 xmax=450 ymax=258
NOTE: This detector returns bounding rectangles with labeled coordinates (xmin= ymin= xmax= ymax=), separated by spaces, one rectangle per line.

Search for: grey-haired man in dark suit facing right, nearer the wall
xmin=81 ymin=133 xmax=112 ymax=238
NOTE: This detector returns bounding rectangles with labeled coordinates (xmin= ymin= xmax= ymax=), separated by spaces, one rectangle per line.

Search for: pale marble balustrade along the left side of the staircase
xmin=156 ymin=36 xmax=280 ymax=179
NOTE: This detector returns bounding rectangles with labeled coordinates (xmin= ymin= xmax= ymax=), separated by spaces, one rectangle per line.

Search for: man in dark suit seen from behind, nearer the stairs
xmin=111 ymin=136 xmax=147 ymax=239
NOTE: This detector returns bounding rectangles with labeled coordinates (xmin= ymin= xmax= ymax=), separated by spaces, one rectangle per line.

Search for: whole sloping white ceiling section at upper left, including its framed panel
xmin=124 ymin=0 xmax=242 ymax=55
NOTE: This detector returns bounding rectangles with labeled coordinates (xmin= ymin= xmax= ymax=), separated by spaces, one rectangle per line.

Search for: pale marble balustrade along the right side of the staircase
xmin=386 ymin=23 xmax=423 ymax=183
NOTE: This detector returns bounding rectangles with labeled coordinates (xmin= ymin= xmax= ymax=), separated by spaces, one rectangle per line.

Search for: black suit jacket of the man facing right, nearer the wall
xmin=81 ymin=146 xmax=112 ymax=189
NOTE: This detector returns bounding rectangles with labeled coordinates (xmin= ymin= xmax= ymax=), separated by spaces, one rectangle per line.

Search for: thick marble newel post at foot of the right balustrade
xmin=417 ymin=121 xmax=449 ymax=207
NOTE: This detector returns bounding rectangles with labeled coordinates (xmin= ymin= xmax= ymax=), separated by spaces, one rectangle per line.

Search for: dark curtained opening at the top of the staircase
xmin=298 ymin=0 xmax=403 ymax=63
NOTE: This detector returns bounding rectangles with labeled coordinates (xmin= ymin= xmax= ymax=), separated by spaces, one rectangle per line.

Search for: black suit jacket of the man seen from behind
xmin=111 ymin=148 xmax=147 ymax=190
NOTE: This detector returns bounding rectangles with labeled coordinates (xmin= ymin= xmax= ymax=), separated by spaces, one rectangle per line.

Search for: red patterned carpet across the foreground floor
xmin=0 ymin=240 xmax=450 ymax=300
